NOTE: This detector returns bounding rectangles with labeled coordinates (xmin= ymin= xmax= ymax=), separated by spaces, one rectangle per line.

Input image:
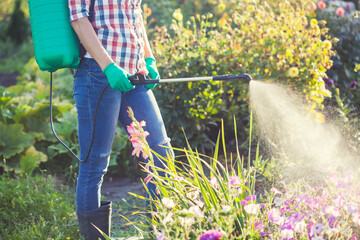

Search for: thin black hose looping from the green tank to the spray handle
xmin=50 ymin=72 xmax=109 ymax=163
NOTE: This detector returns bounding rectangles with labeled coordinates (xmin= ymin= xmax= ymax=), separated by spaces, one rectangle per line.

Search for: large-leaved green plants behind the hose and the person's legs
xmin=0 ymin=58 xmax=130 ymax=174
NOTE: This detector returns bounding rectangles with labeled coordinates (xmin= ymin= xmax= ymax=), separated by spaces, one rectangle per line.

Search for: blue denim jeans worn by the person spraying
xmin=73 ymin=58 xmax=174 ymax=211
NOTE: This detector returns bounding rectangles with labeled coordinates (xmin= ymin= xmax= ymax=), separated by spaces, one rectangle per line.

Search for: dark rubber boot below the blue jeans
xmin=77 ymin=201 xmax=111 ymax=240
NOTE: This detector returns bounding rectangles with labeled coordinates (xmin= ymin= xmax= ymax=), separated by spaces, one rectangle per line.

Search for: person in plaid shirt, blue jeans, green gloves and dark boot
xmin=68 ymin=0 xmax=173 ymax=239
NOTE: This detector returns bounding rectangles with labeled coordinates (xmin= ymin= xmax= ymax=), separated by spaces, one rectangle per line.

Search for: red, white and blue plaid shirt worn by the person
xmin=68 ymin=0 xmax=146 ymax=74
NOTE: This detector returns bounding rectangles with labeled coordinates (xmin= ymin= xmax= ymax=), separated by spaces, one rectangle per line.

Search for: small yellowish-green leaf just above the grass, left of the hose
xmin=20 ymin=146 xmax=48 ymax=175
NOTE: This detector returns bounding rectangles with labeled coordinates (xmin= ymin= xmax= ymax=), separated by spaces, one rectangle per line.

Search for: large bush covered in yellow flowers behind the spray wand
xmin=145 ymin=0 xmax=336 ymax=150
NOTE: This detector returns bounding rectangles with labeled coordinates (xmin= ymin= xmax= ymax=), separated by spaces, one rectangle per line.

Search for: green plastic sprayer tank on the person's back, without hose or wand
xmin=28 ymin=0 xmax=79 ymax=72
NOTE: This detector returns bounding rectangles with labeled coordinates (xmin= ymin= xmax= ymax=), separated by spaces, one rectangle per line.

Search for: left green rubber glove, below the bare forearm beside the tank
xmin=103 ymin=63 xmax=135 ymax=92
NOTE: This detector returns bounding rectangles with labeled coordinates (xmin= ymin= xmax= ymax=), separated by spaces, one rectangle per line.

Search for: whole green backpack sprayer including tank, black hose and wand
xmin=28 ymin=0 xmax=252 ymax=162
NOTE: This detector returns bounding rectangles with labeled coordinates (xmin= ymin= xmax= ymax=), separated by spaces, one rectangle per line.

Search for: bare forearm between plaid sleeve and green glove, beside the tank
xmin=71 ymin=18 xmax=113 ymax=70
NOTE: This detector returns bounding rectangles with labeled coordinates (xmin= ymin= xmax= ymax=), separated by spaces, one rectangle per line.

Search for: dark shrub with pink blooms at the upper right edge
xmin=316 ymin=2 xmax=360 ymax=122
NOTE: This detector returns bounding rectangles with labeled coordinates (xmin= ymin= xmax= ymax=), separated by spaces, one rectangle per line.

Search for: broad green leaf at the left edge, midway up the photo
xmin=0 ymin=122 xmax=34 ymax=158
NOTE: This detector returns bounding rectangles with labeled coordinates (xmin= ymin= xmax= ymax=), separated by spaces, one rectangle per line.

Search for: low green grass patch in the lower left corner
xmin=0 ymin=175 xmax=80 ymax=239
